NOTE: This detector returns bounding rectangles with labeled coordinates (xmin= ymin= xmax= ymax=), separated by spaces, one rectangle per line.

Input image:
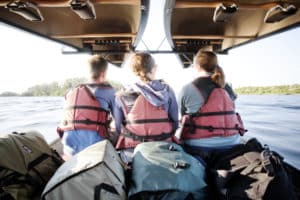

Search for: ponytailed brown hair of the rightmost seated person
xmin=194 ymin=50 xmax=225 ymax=87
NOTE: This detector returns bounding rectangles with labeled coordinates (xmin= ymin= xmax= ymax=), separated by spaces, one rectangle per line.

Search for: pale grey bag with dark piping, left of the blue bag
xmin=42 ymin=140 xmax=126 ymax=200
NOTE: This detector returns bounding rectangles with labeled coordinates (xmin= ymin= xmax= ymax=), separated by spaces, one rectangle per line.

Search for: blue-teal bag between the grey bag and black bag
xmin=128 ymin=141 xmax=206 ymax=200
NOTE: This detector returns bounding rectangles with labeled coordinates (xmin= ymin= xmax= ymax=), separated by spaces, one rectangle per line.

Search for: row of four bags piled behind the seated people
xmin=0 ymin=132 xmax=299 ymax=200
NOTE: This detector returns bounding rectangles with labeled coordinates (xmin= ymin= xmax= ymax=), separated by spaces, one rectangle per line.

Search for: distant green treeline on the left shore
xmin=0 ymin=78 xmax=123 ymax=96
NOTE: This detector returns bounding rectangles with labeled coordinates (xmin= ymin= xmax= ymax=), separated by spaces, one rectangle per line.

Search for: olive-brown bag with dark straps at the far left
xmin=0 ymin=131 xmax=63 ymax=200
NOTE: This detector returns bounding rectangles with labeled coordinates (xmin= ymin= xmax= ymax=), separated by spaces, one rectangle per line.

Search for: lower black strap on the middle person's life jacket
xmin=122 ymin=130 xmax=174 ymax=142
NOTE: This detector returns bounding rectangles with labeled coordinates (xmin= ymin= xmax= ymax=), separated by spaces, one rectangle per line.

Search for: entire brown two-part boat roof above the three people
xmin=0 ymin=0 xmax=300 ymax=67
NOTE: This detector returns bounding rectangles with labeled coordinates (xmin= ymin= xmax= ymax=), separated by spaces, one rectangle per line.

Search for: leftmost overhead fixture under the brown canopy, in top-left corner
xmin=6 ymin=1 xmax=44 ymax=21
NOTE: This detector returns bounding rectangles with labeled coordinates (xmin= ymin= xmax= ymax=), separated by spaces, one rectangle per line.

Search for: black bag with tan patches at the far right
xmin=210 ymin=139 xmax=297 ymax=200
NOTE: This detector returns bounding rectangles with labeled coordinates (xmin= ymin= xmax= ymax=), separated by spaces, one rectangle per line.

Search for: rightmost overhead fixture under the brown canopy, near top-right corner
xmin=264 ymin=5 xmax=298 ymax=23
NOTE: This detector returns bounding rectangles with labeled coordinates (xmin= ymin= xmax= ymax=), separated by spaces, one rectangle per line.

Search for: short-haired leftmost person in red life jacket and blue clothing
xmin=58 ymin=55 xmax=115 ymax=158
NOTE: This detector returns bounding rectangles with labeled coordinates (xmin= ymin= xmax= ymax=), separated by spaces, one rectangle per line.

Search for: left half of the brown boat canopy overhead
xmin=0 ymin=0 xmax=149 ymax=66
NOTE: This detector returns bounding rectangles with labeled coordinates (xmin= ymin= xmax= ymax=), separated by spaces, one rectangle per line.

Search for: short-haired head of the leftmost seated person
xmin=89 ymin=55 xmax=108 ymax=80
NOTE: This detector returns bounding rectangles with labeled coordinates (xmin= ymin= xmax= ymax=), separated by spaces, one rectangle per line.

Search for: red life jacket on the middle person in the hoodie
xmin=116 ymin=92 xmax=174 ymax=149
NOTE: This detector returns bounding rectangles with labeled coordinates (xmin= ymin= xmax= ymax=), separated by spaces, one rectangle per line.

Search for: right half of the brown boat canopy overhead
xmin=164 ymin=0 xmax=300 ymax=67
